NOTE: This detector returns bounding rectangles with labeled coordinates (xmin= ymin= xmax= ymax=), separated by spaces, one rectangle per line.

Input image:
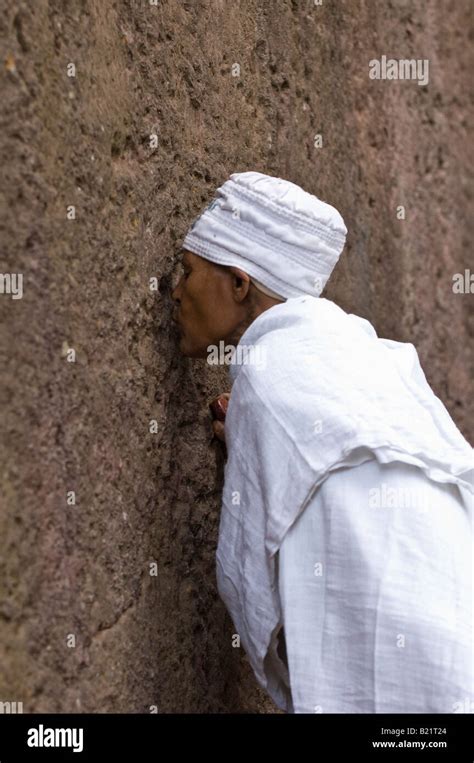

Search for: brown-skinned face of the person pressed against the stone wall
xmin=172 ymin=250 xmax=255 ymax=358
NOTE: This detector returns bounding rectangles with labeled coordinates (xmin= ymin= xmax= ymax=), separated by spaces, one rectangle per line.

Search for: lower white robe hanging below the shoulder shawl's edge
xmin=265 ymin=459 xmax=474 ymax=713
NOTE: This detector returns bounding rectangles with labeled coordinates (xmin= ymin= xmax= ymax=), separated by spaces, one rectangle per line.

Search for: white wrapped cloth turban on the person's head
xmin=183 ymin=172 xmax=347 ymax=299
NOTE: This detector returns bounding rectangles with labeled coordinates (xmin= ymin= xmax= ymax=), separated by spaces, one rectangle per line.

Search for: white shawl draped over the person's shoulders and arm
xmin=216 ymin=296 xmax=474 ymax=708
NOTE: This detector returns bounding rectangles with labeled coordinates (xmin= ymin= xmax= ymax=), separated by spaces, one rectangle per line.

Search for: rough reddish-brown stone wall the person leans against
xmin=0 ymin=0 xmax=474 ymax=713
